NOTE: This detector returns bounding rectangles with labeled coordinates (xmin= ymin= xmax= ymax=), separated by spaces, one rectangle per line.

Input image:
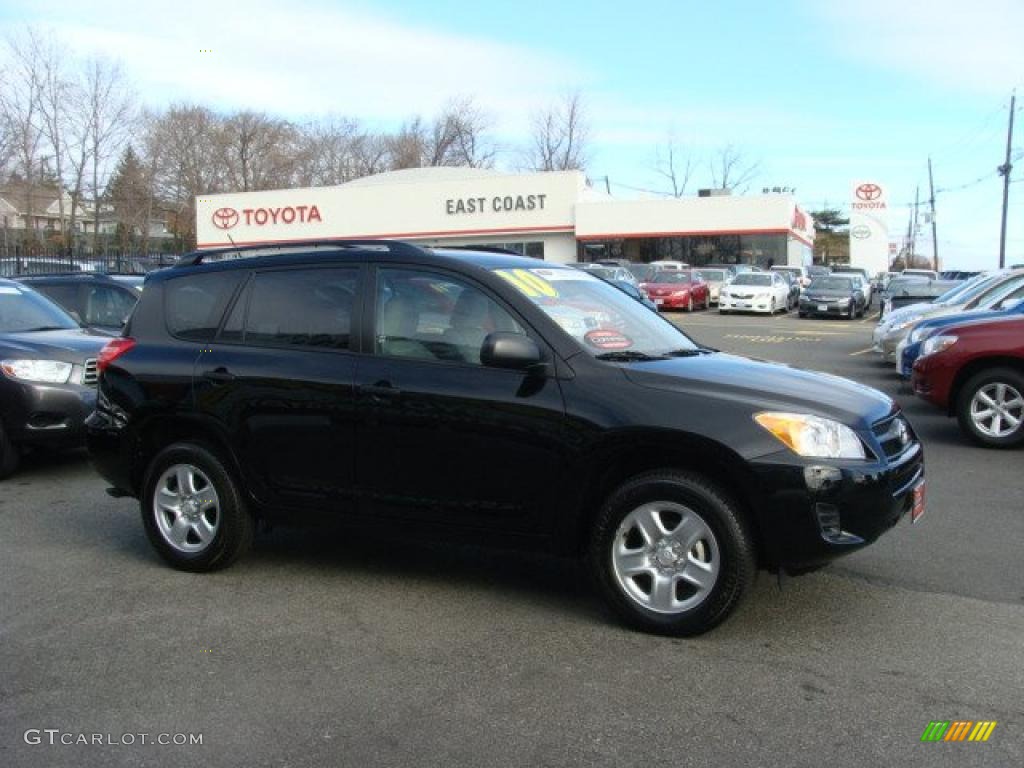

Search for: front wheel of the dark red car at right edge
xmin=956 ymin=368 xmax=1024 ymax=449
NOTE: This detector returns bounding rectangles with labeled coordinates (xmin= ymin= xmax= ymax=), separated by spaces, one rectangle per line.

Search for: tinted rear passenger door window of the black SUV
xmin=243 ymin=268 xmax=358 ymax=349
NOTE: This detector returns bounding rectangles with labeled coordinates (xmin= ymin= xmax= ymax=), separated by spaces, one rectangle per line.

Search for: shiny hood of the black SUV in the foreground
xmin=623 ymin=352 xmax=895 ymax=428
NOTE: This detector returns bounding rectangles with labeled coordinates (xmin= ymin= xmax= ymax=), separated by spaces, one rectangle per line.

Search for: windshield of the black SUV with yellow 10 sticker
xmin=494 ymin=268 xmax=698 ymax=360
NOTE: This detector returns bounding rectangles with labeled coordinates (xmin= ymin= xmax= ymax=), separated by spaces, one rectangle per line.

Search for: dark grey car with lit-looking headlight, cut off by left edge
xmin=0 ymin=278 xmax=110 ymax=478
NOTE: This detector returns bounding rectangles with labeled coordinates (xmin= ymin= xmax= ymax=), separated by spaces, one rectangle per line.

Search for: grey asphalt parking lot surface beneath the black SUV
xmin=0 ymin=312 xmax=1024 ymax=767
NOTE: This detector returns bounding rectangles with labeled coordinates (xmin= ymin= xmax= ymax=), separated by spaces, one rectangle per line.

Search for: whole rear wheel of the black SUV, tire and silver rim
xmin=140 ymin=442 xmax=253 ymax=571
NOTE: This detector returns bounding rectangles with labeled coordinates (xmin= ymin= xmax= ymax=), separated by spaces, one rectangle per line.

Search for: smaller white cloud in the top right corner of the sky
xmin=812 ymin=0 xmax=1024 ymax=93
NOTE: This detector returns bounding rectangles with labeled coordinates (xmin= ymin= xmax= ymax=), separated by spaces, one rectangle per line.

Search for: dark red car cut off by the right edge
xmin=912 ymin=316 xmax=1024 ymax=447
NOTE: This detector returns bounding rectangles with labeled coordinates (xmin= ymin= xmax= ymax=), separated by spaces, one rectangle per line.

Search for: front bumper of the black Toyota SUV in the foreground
xmin=753 ymin=441 xmax=925 ymax=572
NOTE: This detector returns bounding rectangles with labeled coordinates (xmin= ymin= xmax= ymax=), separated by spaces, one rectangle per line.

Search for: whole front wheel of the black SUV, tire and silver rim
xmin=589 ymin=470 xmax=756 ymax=636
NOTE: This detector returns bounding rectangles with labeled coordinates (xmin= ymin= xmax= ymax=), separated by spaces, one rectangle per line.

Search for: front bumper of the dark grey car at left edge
xmin=0 ymin=379 xmax=96 ymax=447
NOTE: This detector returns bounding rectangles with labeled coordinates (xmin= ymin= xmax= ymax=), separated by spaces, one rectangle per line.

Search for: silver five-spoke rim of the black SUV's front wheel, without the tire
xmin=611 ymin=502 xmax=722 ymax=614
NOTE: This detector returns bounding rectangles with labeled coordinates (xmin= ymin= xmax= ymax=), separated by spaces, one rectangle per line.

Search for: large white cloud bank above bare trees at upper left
xmin=2 ymin=0 xmax=584 ymax=131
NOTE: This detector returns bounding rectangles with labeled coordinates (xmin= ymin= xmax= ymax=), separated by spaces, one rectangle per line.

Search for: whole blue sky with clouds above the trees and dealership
xmin=0 ymin=0 xmax=1024 ymax=269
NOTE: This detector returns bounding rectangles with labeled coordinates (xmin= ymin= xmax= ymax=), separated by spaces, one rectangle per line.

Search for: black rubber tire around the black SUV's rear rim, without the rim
xmin=139 ymin=442 xmax=254 ymax=572
